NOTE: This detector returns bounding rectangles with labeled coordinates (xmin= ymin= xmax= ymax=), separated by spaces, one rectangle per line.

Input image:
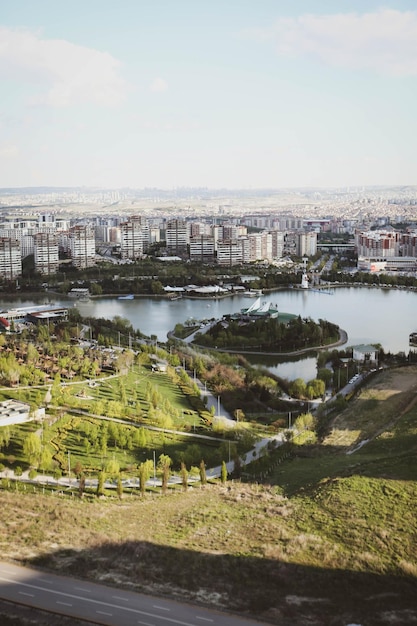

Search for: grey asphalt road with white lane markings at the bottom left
xmin=0 ymin=562 xmax=266 ymax=626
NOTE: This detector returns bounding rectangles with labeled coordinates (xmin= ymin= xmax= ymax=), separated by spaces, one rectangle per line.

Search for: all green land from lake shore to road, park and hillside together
xmin=0 ymin=308 xmax=417 ymax=626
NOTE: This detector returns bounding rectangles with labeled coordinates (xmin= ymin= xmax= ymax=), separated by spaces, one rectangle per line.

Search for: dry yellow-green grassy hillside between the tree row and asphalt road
xmin=0 ymin=369 xmax=417 ymax=626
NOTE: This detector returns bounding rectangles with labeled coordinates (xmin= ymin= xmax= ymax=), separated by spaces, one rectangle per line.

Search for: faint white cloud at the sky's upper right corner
xmin=247 ymin=9 xmax=417 ymax=75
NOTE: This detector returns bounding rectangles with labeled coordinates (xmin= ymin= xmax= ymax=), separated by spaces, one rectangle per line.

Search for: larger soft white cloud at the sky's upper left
xmin=0 ymin=28 xmax=127 ymax=107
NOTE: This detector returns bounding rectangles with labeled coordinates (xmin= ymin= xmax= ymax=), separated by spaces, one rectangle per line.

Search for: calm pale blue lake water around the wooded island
xmin=0 ymin=287 xmax=417 ymax=380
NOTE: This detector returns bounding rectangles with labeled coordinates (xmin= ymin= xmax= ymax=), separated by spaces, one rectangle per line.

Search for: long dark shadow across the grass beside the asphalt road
xmin=21 ymin=536 xmax=417 ymax=626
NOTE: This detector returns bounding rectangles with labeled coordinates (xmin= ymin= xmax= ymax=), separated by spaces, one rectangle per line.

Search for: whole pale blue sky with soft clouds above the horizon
xmin=0 ymin=0 xmax=417 ymax=189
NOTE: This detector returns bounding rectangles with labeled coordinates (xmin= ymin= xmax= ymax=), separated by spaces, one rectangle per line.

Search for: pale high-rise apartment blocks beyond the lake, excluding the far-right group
xmin=0 ymin=214 xmax=317 ymax=280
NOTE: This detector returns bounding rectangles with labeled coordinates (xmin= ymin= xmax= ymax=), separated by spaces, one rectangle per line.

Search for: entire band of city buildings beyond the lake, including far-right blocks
xmin=0 ymin=202 xmax=417 ymax=280
